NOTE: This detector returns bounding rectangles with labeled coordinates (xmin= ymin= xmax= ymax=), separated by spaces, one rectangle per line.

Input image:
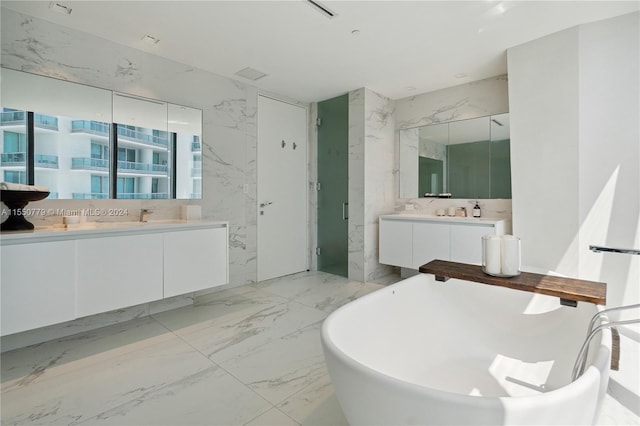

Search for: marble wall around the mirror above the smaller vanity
xmin=393 ymin=75 xmax=511 ymax=225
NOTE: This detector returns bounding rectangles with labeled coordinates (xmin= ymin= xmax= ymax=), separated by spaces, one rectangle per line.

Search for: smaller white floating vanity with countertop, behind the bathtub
xmin=379 ymin=214 xmax=504 ymax=269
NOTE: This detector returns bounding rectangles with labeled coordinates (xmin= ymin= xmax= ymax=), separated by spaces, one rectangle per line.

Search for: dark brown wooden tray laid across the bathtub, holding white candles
xmin=419 ymin=260 xmax=607 ymax=306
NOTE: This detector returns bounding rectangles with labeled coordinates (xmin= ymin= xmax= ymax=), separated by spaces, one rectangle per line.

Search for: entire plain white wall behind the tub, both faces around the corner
xmin=508 ymin=13 xmax=640 ymax=306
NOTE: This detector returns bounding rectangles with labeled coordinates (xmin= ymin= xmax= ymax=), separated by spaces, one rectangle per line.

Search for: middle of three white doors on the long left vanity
xmin=76 ymin=234 xmax=163 ymax=317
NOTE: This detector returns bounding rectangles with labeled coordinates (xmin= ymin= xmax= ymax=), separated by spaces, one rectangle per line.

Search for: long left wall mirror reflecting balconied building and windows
xmin=0 ymin=68 xmax=202 ymax=199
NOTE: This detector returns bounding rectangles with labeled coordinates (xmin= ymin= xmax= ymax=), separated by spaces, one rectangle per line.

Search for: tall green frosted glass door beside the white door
xmin=317 ymin=95 xmax=349 ymax=277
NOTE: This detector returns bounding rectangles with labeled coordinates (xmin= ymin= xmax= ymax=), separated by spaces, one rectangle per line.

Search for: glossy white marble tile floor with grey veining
xmin=1 ymin=272 xmax=640 ymax=426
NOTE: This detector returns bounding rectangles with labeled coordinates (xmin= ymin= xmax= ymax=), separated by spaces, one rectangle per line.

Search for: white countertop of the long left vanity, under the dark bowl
xmin=0 ymin=220 xmax=229 ymax=246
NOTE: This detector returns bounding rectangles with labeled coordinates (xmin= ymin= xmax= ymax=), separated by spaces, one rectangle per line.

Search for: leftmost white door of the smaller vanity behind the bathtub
xmin=379 ymin=219 xmax=413 ymax=268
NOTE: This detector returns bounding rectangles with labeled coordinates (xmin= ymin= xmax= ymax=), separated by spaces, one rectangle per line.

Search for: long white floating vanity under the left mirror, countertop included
xmin=0 ymin=222 xmax=229 ymax=336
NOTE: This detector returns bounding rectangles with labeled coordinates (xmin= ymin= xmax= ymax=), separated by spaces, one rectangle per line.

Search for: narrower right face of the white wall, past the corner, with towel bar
xmin=578 ymin=13 xmax=640 ymax=306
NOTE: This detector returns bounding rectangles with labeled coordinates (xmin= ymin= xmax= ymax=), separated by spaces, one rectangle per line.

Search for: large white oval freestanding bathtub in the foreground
xmin=322 ymin=274 xmax=611 ymax=425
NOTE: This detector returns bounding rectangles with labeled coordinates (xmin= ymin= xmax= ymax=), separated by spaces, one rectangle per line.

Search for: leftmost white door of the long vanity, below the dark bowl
xmin=0 ymin=241 xmax=75 ymax=336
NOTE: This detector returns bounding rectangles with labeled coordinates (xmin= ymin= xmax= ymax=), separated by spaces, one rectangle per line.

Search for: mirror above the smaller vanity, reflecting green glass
xmin=400 ymin=113 xmax=511 ymax=199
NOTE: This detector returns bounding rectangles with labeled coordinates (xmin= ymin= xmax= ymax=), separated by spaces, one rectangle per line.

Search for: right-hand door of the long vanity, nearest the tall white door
xmin=164 ymin=226 xmax=229 ymax=297
